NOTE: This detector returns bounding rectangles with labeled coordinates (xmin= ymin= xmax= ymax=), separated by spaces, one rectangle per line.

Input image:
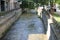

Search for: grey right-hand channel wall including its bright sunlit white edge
xmin=42 ymin=12 xmax=58 ymax=40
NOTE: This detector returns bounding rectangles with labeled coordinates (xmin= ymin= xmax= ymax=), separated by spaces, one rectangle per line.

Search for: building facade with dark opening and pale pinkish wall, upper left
xmin=0 ymin=0 xmax=19 ymax=12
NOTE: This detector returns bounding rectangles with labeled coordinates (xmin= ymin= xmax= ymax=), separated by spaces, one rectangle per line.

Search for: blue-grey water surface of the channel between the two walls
xmin=2 ymin=14 xmax=44 ymax=40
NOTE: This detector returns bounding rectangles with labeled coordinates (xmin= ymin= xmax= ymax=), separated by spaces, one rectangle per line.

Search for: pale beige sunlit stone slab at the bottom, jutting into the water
xmin=28 ymin=34 xmax=48 ymax=40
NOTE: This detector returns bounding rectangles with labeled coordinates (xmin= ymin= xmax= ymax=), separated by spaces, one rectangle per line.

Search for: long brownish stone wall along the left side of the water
xmin=0 ymin=9 xmax=21 ymax=38
